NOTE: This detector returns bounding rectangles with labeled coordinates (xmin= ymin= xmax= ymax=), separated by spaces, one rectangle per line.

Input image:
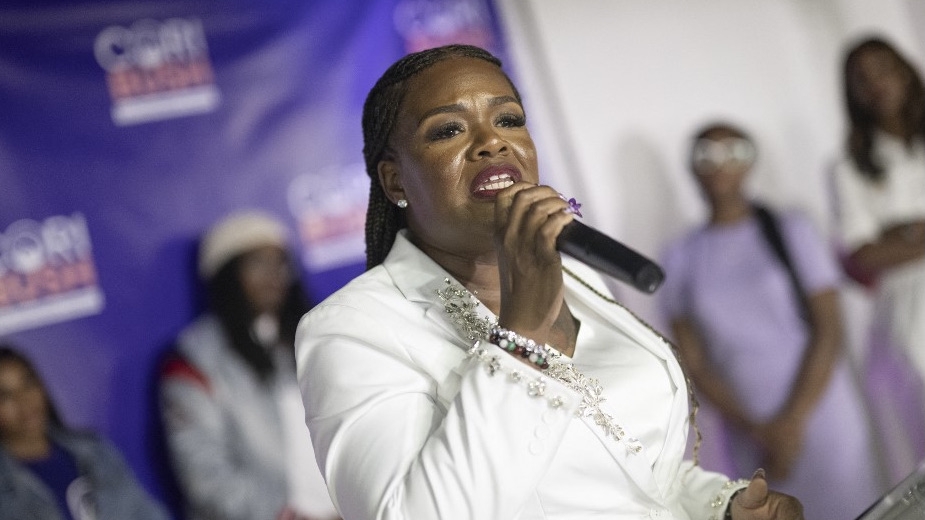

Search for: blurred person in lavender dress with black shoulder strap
xmin=659 ymin=123 xmax=879 ymax=518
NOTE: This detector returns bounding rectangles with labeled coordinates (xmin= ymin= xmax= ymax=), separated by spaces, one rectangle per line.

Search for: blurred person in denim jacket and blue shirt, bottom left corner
xmin=0 ymin=345 xmax=168 ymax=520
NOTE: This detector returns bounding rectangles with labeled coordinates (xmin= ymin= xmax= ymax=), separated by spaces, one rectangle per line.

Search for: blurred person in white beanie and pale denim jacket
xmin=160 ymin=211 xmax=337 ymax=520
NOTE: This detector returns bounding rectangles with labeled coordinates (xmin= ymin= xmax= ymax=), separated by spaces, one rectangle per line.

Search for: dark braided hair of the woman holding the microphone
xmin=363 ymin=44 xmax=520 ymax=269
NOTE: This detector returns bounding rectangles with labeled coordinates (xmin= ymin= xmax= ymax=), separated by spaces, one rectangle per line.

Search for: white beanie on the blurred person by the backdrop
xmin=199 ymin=210 xmax=289 ymax=280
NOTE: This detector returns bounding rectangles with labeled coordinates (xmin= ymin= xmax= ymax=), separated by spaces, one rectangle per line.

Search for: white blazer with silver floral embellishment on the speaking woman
xmin=296 ymin=234 xmax=745 ymax=520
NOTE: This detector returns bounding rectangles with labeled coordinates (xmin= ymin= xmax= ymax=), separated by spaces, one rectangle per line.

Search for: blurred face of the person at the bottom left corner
xmin=0 ymin=360 xmax=48 ymax=442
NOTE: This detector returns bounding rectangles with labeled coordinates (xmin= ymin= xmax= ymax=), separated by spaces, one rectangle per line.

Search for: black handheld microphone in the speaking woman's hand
xmin=556 ymin=220 xmax=665 ymax=294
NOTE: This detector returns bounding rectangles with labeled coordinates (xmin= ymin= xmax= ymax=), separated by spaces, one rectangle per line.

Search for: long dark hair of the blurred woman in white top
xmin=842 ymin=37 xmax=925 ymax=181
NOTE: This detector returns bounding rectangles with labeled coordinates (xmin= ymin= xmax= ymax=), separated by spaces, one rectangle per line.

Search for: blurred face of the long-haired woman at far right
xmin=849 ymin=49 xmax=910 ymax=124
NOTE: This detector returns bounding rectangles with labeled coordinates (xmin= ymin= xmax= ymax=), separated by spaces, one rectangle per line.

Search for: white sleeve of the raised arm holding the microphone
xmin=297 ymin=305 xmax=579 ymax=520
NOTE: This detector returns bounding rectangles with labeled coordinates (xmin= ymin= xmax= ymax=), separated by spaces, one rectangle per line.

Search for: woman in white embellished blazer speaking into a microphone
xmin=297 ymin=45 xmax=802 ymax=520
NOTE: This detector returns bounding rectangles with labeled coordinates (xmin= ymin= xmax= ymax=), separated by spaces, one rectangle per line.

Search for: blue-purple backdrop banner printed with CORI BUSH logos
xmin=0 ymin=0 xmax=504 ymax=512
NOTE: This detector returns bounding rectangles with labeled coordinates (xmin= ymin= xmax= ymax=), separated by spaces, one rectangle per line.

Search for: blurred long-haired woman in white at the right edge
xmin=834 ymin=38 xmax=925 ymax=480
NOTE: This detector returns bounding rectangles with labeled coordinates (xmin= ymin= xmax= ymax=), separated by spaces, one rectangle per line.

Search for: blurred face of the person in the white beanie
xmin=239 ymin=246 xmax=292 ymax=314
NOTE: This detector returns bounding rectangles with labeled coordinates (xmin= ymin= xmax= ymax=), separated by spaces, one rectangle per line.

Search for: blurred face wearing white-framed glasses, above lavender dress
xmin=692 ymin=128 xmax=755 ymax=205
